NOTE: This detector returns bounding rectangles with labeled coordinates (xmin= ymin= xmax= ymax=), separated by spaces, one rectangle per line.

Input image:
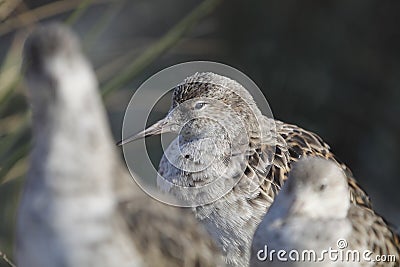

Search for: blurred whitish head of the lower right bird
xmin=281 ymin=157 xmax=350 ymax=218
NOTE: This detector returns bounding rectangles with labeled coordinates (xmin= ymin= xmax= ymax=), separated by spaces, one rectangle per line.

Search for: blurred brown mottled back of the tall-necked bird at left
xmin=120 ymin=197 xmax=223 ymax=267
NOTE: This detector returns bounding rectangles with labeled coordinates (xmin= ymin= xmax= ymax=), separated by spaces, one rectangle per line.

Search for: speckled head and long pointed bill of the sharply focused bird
xmin=119 ymin=72 xmax=262 ymax=145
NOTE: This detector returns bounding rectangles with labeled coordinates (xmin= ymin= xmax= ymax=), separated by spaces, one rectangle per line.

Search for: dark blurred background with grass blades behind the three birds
xmin=0 ymin=0 xmax=400 ymax=266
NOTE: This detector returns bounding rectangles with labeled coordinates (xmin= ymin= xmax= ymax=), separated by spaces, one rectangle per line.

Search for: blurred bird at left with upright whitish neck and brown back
xmin=15 ymin=25 xmax=221 ymax=267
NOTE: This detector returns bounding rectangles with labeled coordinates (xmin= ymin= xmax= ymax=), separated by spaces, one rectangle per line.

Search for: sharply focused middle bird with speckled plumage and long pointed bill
xmin=121 ymin=72 xmax=370 ymax=267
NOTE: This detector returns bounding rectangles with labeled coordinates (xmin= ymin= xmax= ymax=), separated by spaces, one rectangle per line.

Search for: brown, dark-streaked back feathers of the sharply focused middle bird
xmin=246 ymin=120 xmax=371 ymax=208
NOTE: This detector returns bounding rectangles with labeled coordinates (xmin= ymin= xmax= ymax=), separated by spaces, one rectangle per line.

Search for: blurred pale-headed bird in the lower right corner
xmin=251 ymin=158 xmax=400 ymax=267
